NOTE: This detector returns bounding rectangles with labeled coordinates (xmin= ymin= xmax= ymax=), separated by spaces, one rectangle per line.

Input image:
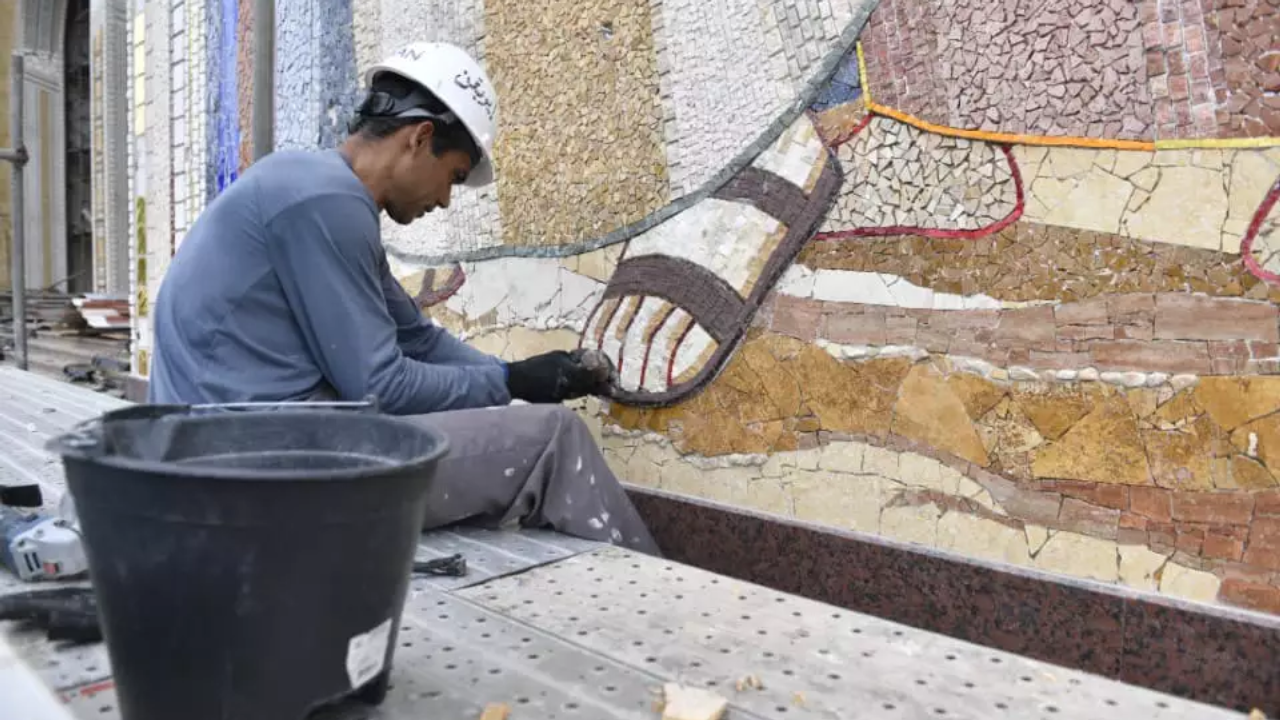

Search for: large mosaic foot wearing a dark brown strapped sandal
xmin=581 ymin=117 xmax=840 ymax=405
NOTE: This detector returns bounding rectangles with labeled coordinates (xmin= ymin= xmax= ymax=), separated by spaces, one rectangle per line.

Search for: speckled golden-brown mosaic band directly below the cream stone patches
xmin=799 ymin=222 xmax=1280 ymax=302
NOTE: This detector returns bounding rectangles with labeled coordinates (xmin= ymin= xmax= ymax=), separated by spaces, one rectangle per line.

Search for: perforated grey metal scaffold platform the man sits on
xmin=0 ymin=368 xmax=1243 ymax=720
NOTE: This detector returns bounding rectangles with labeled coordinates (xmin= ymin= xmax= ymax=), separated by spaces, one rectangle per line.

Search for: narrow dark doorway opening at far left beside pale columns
xmin=55 ymin=0 xmax=93 ymax=295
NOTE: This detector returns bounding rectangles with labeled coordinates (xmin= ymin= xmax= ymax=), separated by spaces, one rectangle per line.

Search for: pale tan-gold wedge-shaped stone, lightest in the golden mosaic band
xmin=892 ymin=363 xmax=988 ymax=465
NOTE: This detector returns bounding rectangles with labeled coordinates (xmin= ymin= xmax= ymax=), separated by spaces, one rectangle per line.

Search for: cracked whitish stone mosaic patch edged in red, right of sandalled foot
xmin=820 ymin=117 xmax=1021 ymax=237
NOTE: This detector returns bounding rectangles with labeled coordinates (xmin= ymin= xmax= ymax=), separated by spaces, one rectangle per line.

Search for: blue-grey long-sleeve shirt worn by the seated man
xmin=148 ymin=150 xmax=511 ymax=414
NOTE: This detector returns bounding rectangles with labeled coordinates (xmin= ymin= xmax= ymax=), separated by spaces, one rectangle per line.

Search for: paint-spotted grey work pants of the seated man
xmin=404 ymin=405 xmax=659 ymax=555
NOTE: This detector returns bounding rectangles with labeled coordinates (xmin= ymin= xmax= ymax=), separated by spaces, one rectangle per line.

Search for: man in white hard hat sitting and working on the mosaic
xmin=148 ymin=44 xmax=657 ymax=553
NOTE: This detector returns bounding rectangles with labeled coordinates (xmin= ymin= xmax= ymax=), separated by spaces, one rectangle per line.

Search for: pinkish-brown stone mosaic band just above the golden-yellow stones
xmin=760 ymin=293 xmax=1280 ymax=375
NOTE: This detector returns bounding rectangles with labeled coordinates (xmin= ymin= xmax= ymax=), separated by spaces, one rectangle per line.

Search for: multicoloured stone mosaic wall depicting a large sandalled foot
xmin=122 ymin=0 xmax=1280 ymax=612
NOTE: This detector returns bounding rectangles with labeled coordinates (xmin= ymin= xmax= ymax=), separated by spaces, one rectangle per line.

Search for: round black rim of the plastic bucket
xmin=45 ymin=410 xmax=449 ymax=483
